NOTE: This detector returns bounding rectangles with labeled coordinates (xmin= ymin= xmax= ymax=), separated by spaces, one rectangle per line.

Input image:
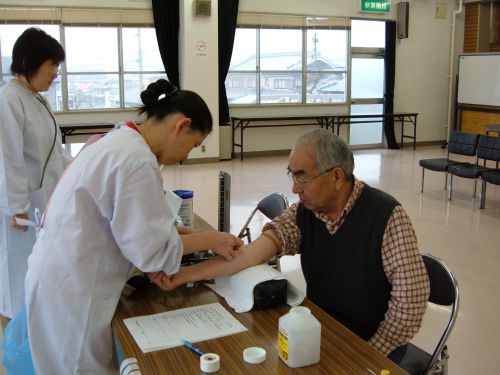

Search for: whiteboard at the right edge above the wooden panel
xmin=457 ymin=53 xmax=500 ymax=107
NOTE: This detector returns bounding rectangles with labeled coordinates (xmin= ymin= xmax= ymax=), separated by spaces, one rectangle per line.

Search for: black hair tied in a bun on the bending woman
xmin=139 ymin=79 xmax=213 ymax=134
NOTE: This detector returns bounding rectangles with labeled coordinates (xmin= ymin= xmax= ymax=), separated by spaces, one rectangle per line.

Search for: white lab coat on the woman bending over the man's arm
xmin=26 ymin=126 xmax=182 ymax=375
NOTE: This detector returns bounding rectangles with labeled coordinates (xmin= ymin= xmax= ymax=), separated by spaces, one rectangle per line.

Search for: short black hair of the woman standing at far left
xmin=10 ymin=27 xmax=66 ymax=81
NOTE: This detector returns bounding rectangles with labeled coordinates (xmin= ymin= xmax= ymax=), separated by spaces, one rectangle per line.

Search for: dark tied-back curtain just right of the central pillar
xmin=219 ymin=0 xmax=239 ymax=124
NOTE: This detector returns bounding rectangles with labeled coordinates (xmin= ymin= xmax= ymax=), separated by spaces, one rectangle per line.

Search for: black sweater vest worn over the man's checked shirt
xmin=296 ymin=184 xmax=399 ymax=340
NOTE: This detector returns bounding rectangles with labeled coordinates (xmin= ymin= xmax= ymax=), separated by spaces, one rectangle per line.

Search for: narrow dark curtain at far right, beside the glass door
xmin=384 ymin=21 xmax=399 ymax=149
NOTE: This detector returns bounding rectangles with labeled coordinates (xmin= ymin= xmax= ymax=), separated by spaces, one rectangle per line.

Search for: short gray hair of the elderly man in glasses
xmin=294 ymin=128 xmax=354 ymax=180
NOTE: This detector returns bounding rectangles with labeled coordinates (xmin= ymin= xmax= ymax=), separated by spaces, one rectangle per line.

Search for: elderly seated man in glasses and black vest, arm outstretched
xmin=151 ymin=129 xmax=429 ymax=363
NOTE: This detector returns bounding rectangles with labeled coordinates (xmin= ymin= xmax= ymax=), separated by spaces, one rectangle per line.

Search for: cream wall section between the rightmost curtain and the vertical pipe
xmin=394 ymin=0 xmax=460 ymax=141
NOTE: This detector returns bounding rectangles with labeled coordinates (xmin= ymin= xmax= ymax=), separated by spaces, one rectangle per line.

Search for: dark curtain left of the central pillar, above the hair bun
xmin=153 ymin=0 xmax=180 ymax=88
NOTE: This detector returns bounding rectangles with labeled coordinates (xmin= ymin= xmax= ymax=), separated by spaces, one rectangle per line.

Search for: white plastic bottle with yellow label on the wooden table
xmin=278 ymin=306 xmax=321 ymax=367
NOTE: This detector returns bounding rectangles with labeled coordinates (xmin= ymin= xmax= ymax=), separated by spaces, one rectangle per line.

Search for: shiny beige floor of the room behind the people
xmin=0 ymin=147 xmax=500 ymax=375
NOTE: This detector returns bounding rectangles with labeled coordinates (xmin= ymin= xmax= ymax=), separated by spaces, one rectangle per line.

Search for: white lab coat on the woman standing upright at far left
xmin=0 ymin=81 xmax=70 ymax=318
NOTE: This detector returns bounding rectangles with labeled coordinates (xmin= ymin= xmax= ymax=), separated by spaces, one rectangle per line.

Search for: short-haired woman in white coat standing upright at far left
xmin=0 ymin=28 xmax=70 ymax=326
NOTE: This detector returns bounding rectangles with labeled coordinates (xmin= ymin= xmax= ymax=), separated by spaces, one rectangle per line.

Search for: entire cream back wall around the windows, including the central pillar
xmin=0 ymin=0 xmax=463 ymax=154
